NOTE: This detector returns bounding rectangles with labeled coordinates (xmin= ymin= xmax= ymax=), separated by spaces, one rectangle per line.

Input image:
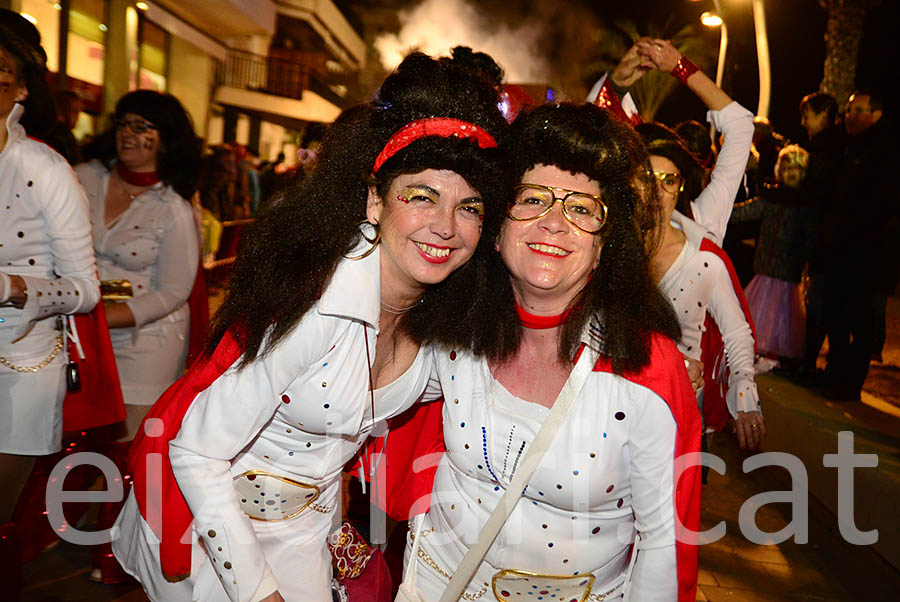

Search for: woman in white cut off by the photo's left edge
xmin=0 ymin=16 xmax=100 ymax=599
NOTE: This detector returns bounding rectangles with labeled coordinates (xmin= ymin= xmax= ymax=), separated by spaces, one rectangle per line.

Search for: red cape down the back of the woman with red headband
xmin=128 ymin=332 xmax=241 ymax=581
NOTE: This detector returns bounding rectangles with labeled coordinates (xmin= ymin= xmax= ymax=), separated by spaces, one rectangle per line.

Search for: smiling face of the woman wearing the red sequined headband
xmin=366 ymin=169 xmax=484 ymax=295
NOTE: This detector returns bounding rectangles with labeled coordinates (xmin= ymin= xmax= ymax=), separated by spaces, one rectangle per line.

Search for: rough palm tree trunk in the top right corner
xmin=819 ymin=0 xmax=882 ymax=106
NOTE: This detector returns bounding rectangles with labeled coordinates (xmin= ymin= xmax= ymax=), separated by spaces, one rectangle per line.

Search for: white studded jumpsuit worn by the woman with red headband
xmin=113 ymin=237 xmax=429 ymax=602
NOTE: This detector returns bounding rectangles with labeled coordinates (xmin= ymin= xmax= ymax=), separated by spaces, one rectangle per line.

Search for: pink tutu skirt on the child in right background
xmin=744 ymin=275 xmax=806 ymax=358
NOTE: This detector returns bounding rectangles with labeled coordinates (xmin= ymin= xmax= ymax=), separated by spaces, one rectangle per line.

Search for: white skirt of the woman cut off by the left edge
xmin=0 ymin=323 xmax=66 ymax=456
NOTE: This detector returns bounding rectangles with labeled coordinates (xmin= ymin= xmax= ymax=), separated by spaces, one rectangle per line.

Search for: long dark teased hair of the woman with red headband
xmin=207 ymin=53 xmax=507 ymax=366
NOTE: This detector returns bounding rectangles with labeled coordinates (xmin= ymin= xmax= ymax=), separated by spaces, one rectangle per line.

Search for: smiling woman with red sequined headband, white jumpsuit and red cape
xmin=113 ymin=54 xmax=506 ymax=602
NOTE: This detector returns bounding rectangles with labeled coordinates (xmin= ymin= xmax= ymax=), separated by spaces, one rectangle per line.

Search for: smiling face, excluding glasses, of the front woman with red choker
xmin=499 ymin=164 xmax=608 ymax=311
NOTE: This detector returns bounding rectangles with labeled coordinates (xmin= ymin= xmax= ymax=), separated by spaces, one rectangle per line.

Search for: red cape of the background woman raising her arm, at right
xmin=700 ymin=238 xmax=756 ymax=431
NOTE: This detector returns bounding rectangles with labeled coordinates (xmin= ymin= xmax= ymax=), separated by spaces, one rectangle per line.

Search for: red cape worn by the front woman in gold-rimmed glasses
xmin=363 ymin=336 xmax=701 ymax=602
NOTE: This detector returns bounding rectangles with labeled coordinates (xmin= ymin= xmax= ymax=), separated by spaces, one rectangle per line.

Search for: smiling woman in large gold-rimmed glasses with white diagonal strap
xmin=404 ymin=105 xmax=700 ymax=602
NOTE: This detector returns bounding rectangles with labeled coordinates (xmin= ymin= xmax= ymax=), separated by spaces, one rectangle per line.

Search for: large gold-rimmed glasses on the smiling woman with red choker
xmin=506 ymin=184 xmax=607 ymax=234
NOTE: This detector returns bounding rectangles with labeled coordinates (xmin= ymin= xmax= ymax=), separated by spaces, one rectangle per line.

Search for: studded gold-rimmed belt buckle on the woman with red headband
xmin=233 ymin=470 xmax=321 ymax=521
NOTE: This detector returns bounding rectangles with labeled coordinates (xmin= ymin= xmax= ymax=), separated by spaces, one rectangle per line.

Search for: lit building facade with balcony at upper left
xmin=6 ymin=0 xmax=366 ymax=163
